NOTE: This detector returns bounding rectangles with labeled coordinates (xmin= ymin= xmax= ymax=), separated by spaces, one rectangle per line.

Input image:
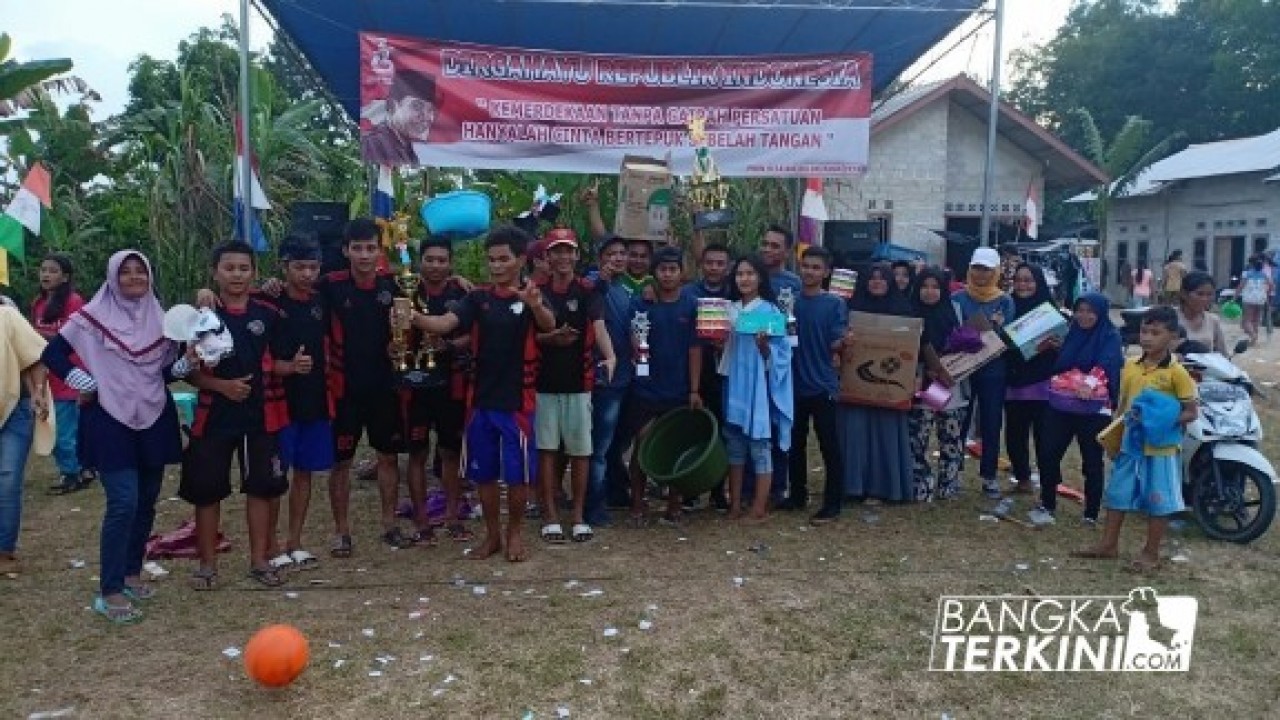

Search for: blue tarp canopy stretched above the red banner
xmin=260 ymin=0 xmax=983 ymax=118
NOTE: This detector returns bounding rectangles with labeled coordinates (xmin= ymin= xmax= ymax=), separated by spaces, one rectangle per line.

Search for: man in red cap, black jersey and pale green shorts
xmin=534 ymin=228 xmax=617 ymax=543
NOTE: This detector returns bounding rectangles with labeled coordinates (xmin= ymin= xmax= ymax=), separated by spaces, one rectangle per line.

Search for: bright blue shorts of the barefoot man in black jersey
xmin=462 ymin=410 xmax=538 ymax=486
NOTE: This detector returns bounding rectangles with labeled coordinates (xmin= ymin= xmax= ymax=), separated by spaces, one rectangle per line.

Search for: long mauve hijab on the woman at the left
xmin=59 ymin=250 xmax=177 ymax=430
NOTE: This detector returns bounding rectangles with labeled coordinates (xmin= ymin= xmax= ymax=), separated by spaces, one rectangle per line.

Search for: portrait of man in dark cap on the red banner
xmin=360 ymin=67 xmax=440 ymax=165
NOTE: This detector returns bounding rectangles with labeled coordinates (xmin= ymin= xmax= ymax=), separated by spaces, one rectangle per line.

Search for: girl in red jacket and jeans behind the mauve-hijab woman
xmin=31 ymin=252 xmax=93 ymax=495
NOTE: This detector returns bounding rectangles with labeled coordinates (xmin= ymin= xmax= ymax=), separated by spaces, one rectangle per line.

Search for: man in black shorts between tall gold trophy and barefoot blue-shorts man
xmin=402 ymin=238 xmax=474 ymax=542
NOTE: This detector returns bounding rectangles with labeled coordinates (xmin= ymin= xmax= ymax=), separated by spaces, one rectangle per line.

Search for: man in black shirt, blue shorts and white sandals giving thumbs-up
xmin=269 ymin=236 xmax=334 ymax=570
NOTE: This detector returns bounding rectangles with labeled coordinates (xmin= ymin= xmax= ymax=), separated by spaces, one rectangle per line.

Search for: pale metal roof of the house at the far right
xmin=1068 ymin=128 xmax=1280 ymax=202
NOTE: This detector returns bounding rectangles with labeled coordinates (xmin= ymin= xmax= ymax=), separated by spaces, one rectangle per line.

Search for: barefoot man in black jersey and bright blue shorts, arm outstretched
xmin=412 ymin=225 xmax=556 ymax=562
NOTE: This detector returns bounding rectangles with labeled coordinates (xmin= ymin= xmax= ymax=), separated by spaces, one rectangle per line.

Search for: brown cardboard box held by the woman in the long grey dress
xmin=840 ymin=313 xmax=924 ymax=410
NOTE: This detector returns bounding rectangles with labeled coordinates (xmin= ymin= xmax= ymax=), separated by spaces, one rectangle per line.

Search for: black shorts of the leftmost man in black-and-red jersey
xmin=178 ymin=432 xmax=289 ymax=507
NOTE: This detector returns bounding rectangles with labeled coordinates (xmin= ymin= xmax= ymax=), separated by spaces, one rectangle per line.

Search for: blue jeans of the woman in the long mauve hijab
xmin=99 ymin=466 xmax=164 ymax=596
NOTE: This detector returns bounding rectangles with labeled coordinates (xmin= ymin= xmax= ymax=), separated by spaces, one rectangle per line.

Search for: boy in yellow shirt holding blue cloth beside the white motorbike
xmin=1071 ymin=307 xmax=1196 ymax=573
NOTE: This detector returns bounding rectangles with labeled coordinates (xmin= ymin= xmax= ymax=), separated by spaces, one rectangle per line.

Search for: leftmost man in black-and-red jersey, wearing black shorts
xmin=178 ymin=241 xmax=304 ymax=589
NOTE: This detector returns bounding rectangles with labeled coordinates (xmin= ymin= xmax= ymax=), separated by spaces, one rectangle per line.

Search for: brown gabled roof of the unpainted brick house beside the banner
xmin=872 ymin=74 xmax=1107 ymax=187
